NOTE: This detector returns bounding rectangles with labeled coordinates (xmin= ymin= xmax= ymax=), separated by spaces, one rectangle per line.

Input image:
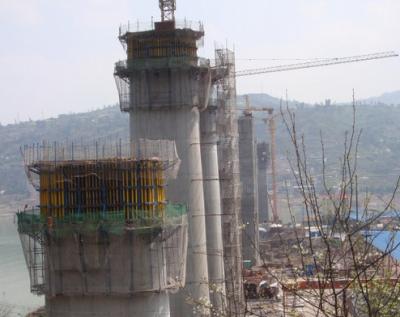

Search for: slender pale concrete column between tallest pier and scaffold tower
xmin=200 ymin=106 xmax=225 ymax=312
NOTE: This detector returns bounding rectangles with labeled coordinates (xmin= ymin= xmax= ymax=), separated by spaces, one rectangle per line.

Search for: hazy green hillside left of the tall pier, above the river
xmin=0 ymin=106 xmax=128 ymax=203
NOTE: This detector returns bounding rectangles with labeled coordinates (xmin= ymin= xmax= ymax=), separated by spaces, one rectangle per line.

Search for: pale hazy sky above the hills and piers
xmin=0 ymin=0 xmax=400 ymax=124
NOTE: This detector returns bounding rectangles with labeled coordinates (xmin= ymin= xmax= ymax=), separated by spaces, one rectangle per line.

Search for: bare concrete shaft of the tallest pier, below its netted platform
xmin=130 ymin=107 xmax=209 ymax=316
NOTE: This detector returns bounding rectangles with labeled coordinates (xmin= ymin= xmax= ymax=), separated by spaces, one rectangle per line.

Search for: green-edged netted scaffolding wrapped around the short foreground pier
xmin=17 ymin=204 xmax=187 ymax=296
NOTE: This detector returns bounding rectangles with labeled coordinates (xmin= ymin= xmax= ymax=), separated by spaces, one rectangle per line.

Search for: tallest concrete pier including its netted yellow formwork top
xmin=115 ymin=21 xmax=212 ymax=317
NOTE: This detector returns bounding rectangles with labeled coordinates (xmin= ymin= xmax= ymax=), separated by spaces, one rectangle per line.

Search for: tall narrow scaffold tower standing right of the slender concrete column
xmin=214 ymin=49 xmax=244 ymax=316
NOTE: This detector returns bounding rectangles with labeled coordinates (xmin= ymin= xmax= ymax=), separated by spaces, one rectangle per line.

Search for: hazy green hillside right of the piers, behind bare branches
xmin=253 ymin=105 xmax=400 ymax=194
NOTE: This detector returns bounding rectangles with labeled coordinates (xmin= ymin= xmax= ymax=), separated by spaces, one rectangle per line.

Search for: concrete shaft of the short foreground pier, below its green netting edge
xmin=45 ymin=227 xmax=174 ymax=317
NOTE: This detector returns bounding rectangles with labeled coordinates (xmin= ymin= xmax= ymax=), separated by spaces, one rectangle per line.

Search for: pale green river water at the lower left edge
xmin=0 ymin=214 xmax=44 ymax=316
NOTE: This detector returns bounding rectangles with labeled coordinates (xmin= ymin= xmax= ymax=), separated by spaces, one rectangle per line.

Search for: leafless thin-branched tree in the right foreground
xmin=253 ymin=97 xmax=400 ymax=317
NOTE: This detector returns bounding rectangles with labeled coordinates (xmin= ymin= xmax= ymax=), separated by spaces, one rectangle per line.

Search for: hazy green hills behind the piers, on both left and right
xmin=0 ymin=94 xmax=400 ymax=203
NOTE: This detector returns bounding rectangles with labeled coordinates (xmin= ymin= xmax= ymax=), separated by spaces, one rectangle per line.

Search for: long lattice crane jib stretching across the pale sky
xmin=235 ymin=51 xmax=399 ymax=77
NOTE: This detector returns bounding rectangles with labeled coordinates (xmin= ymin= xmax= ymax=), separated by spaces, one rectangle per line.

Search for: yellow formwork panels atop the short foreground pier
xmin=35 ymin=159 xmax=166 ymax=220
